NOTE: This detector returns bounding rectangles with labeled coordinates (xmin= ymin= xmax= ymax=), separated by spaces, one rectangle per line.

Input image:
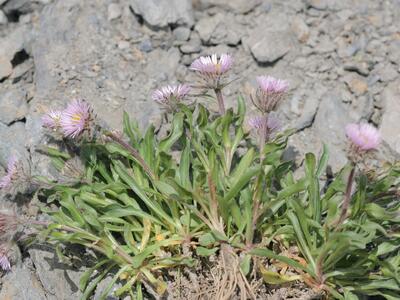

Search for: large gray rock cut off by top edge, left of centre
xmin=130 ymin=0 xmax=194 ymax=27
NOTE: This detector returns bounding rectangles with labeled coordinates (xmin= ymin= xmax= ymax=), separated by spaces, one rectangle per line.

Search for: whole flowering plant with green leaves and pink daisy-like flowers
xmin=0 ymin=54 xmax=400 ymax=299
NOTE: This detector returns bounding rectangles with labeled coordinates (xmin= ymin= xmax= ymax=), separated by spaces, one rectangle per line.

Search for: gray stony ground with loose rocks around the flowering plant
xmin=0 ymin=0 xmax=400 ymax=300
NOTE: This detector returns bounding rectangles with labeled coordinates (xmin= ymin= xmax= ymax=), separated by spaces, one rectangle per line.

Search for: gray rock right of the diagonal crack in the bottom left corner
xmin=29 ymin=249 xmax=82 ymax=300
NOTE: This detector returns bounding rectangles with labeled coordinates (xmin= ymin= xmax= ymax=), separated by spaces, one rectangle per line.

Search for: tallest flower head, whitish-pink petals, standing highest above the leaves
xmin=190 ymin=54 xmax=233 ymax=89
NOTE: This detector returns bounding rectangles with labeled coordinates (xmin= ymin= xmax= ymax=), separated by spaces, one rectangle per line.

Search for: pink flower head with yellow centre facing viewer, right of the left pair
xmin=60 ymin=99 xmax=93 ymax=138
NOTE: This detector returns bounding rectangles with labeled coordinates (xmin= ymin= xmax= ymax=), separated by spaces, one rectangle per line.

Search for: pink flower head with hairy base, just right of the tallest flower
xmin=252 ymin=76 xmax=289 ymax=113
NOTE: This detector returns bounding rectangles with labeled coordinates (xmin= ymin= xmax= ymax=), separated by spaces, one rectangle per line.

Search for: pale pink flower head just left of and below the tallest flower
xmin=152 ymin=84 xmax=190 ymax=110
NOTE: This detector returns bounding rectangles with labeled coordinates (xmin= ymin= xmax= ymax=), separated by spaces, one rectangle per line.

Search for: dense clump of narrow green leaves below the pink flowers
xmin=37 ymin=99 xmax=400 ymax=299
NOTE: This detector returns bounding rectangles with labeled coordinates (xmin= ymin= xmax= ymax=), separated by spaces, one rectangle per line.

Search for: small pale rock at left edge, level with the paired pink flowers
xmin=0 ymin=89 xmax=28 ymax=125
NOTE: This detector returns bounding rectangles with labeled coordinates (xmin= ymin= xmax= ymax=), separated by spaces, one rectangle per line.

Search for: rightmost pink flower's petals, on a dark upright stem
xmin=345 ymin=123 xmax=381 ymax=152
